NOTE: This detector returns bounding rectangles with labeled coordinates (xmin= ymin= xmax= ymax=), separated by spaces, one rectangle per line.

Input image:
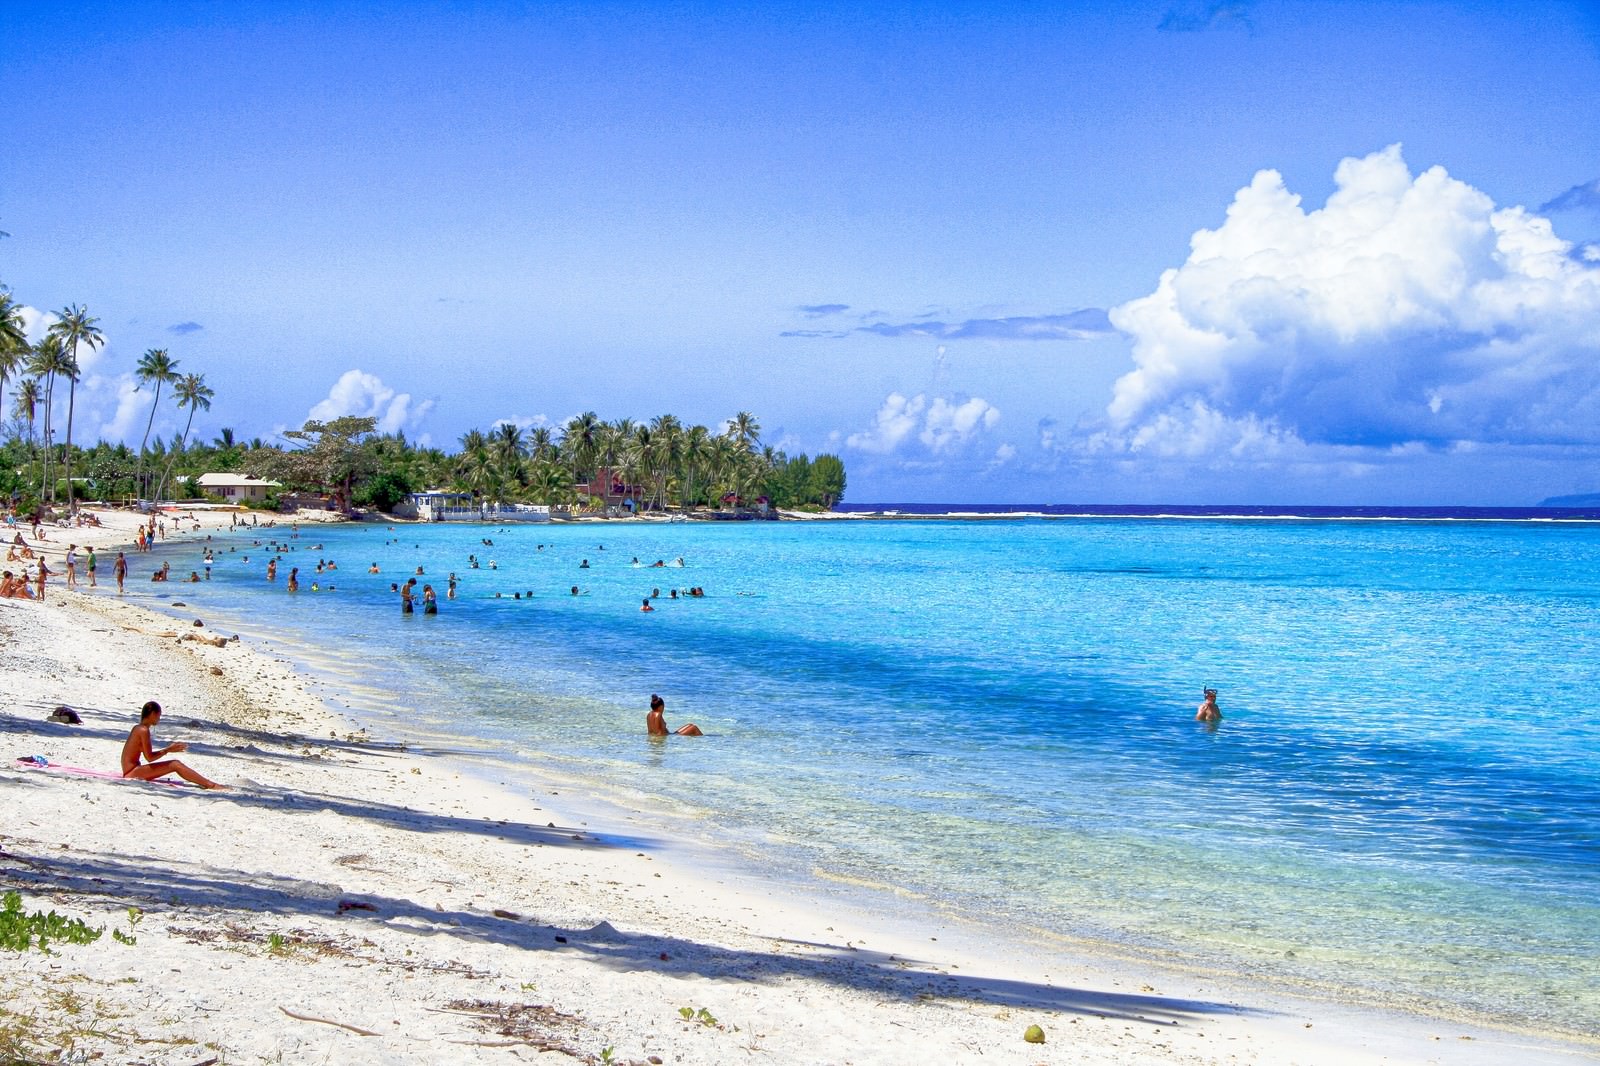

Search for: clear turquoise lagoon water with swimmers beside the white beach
xmin=152 ymin=520 xmax=1600 ymax=1036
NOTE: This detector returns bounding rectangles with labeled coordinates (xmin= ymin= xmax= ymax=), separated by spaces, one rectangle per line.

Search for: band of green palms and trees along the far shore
xmin=0 ymin=275 xmax=845 ymax=512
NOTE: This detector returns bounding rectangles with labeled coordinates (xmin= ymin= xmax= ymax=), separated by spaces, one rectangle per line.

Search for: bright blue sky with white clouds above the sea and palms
xmin=0 ymin=0 xmax=1600 ymax=504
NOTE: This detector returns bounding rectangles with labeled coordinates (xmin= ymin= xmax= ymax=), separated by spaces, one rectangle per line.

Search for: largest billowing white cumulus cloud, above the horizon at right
xmin=1101 ymin=146 xmax=1600 ymax=455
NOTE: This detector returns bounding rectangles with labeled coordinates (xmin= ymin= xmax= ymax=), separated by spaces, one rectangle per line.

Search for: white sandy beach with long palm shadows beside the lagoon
xmin=0 ymin=514 xmax=1595 ymax=1064
